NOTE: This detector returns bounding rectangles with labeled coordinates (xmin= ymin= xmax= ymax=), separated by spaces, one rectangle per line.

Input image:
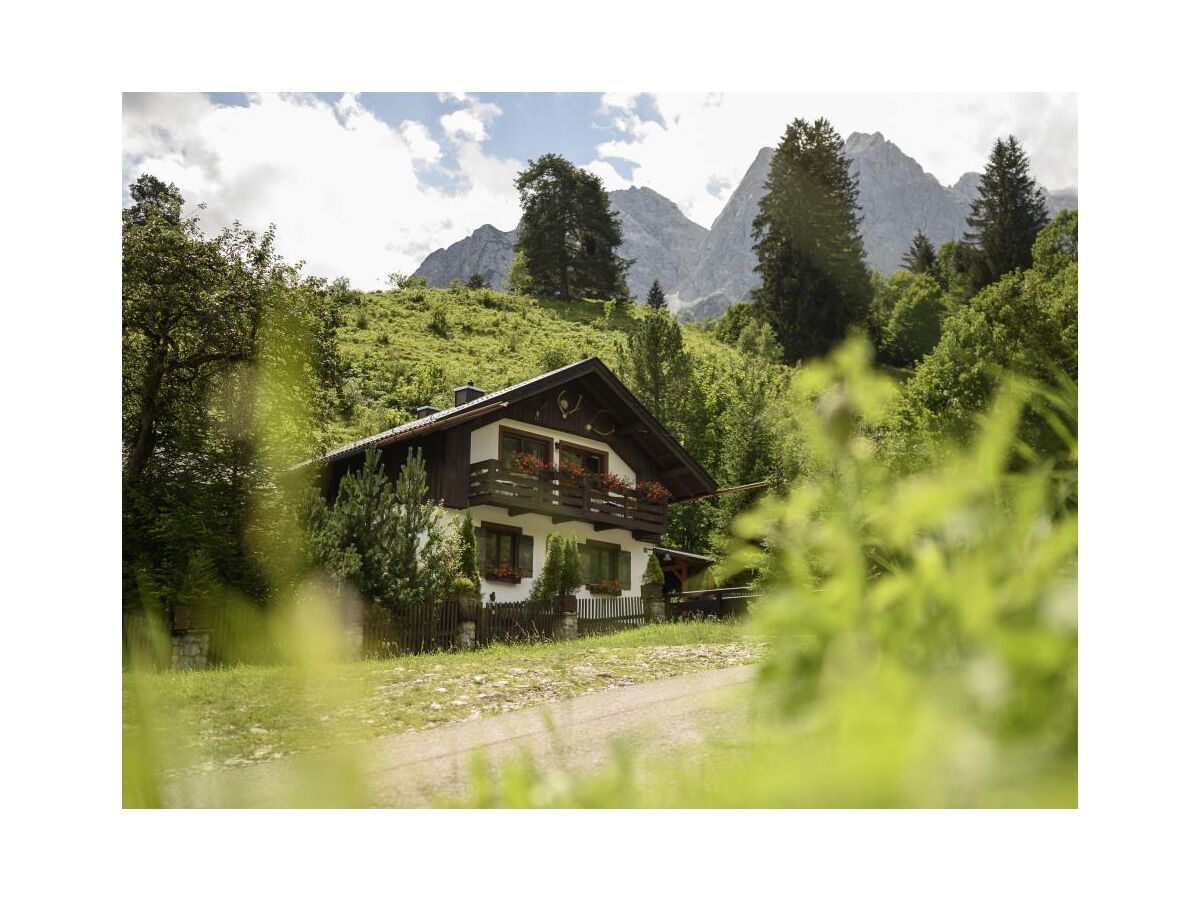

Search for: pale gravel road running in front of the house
xmin=168 ymin=666 xmax=755 ymax=806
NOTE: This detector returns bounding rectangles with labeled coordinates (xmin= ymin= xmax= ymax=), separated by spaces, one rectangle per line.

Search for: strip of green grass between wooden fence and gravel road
xmin=122 ymin=622 xmax=764 ymax=776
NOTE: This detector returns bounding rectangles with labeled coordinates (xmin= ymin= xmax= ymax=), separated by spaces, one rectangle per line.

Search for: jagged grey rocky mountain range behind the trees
xmin=416 ymin=132 xmax=1079 ymax=319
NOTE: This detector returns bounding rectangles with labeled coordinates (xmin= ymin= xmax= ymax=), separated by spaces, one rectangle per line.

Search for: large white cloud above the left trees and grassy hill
xmin=122 ymin=95 xmax=521 ymax=288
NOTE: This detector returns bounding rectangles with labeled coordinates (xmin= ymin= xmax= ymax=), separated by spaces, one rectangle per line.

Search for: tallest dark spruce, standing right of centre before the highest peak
xmin=754 ymin=119 xmax=871 ymax=362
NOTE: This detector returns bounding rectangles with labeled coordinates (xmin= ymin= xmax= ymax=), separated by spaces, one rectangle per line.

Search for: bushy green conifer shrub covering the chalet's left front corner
xmin=304 ymin=448 xmax=456 ymax=610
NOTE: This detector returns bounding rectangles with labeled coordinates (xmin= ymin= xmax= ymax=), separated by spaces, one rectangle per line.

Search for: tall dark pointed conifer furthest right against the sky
xmin=966 ymin=136 xmax=1050 ymax=288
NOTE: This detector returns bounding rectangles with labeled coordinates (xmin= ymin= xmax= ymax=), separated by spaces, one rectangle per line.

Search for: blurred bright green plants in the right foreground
xmin=460 ymin=342 xmax=1078 ymax=806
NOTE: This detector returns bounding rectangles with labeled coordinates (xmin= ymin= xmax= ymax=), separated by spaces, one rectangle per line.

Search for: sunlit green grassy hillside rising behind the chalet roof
xmin=335 ymin=288 xmax=739 ymax=443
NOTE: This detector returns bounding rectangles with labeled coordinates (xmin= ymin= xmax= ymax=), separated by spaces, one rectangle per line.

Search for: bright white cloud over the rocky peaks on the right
xmin=588 ymin=94 xmax=1078 ymax=227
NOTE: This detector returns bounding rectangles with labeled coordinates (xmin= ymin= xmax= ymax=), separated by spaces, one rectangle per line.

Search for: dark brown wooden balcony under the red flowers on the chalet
xmin=467 ymin=460 xmax=667 ymax=540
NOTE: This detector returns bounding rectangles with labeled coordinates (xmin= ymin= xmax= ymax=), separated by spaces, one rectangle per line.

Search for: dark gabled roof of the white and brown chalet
xmin=306 ymin=356 xmax=716 ymax=500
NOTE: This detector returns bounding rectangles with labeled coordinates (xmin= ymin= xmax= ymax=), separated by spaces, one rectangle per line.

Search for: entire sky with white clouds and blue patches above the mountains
xmin=121 ymin=92 xmax=1078 ymax=288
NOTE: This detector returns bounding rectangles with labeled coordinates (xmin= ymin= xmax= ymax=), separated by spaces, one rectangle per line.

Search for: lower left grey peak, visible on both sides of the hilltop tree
xmin=415 ymin=187 xmax=708 ymax=298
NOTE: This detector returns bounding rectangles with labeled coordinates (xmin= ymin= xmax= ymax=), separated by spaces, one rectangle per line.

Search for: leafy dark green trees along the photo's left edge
xmin=121 ymin=175 xmax=345 ymax=606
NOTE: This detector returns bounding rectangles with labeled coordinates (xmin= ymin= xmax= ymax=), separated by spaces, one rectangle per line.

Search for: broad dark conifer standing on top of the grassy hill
xmin=516 ymin=154 xmax=630 ymax=299
